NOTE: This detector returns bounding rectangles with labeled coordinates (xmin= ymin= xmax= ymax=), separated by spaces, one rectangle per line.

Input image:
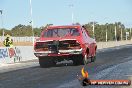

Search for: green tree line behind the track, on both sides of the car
xmin=0 ymin=22 xmax=132 ymax=41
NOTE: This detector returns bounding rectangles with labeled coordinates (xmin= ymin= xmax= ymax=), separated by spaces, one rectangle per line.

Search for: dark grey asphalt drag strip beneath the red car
xmin=0 ymin=45 xmax=132 ymax=88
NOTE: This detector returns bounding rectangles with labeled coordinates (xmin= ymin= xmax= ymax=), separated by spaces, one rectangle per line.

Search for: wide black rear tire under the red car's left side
xmin=39 ymin=57 xmax=56 ymax=68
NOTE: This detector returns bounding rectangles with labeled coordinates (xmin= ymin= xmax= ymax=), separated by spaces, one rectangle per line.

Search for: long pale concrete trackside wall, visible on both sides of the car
xmin=0 ymin=40 xmax=132 ymax=63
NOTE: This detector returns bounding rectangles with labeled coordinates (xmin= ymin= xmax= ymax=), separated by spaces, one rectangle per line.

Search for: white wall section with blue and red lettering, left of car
xmin=0 ymin=46 xmax=37 ymax=63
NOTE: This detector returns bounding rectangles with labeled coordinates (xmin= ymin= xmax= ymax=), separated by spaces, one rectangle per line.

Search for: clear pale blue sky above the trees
xmin=0 ymin=0 xmax=132 ymax=29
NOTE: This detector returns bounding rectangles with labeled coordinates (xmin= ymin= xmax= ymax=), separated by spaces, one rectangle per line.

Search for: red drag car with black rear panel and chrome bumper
xmin=34 ymin=25 xmax=97 ymax=67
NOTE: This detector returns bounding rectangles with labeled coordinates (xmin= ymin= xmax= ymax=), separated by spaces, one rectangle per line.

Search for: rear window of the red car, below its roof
xmin=44 ymin=28 xmax=79 ymax=37
